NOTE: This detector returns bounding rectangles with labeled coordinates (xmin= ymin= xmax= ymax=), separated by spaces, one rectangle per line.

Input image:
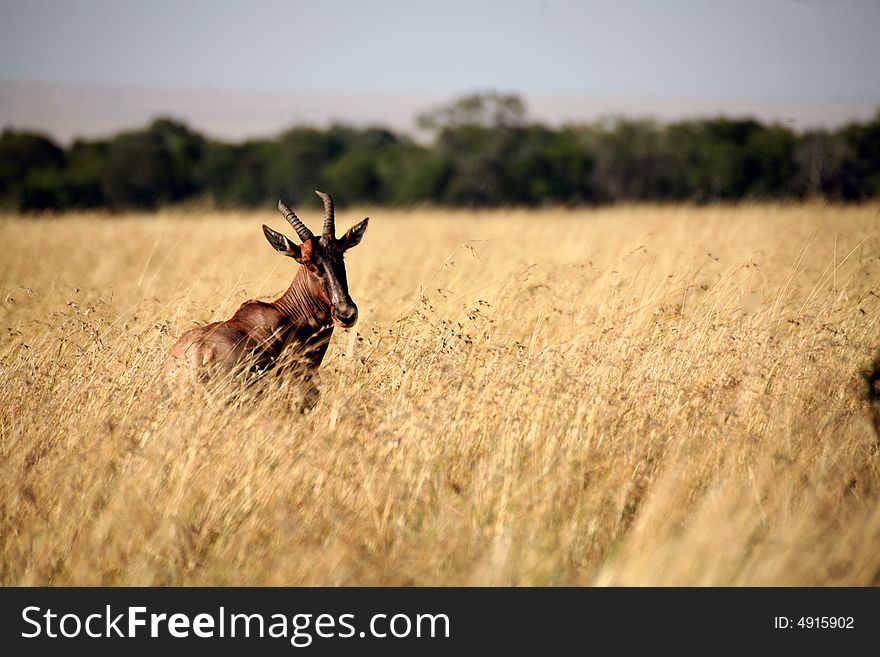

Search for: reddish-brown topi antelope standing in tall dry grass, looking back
xmin=165 ymin=192 xmax=369 ymax=400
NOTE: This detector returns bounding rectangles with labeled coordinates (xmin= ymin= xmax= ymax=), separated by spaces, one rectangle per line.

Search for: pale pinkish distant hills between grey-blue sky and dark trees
xmin=0 ymin=80 xmax=880 ymax=144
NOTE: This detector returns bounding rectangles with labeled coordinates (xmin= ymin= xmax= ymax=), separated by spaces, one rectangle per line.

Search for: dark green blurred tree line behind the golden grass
xmin=0 ymin=93 xmax=880 ymax=212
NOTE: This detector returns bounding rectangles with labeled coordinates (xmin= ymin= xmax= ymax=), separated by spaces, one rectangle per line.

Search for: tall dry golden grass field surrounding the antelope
xmin=0 ymin=205 xmax=880 ymax=585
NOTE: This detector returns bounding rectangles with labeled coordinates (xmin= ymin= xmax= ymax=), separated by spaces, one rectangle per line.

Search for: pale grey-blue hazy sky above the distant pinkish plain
xmin=0 ymin=0 xmax=880 ymax=140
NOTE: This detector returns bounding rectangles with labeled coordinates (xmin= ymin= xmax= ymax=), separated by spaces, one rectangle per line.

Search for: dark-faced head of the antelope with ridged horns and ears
xmin=263 ymin=191 xmax=369 ymax=328
